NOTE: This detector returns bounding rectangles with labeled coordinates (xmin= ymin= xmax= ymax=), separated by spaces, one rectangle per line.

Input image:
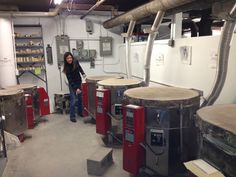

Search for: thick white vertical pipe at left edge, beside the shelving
xmin=0 ymin=18 xmax=16 ymax=88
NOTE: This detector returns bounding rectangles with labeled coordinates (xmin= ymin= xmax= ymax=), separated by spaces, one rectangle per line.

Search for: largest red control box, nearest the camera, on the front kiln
xmin=123 ymin=105 xmax=145 ymax=175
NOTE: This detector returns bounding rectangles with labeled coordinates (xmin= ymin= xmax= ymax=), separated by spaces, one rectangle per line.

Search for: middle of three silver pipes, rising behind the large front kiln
xmin=144 ymin=11 xmax=165 ymax=86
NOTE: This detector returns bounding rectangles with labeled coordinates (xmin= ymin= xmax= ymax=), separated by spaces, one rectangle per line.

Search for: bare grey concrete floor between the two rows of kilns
xmin=2 ymin=114 xmax=129 ymax=177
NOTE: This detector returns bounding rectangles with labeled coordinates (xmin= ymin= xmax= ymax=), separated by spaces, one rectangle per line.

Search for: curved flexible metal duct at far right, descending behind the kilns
xmin=202 ymin=3 xmax=236 ymax=107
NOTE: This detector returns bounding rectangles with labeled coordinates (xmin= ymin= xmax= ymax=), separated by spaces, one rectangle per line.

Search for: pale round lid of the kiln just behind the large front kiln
xmin=98 ymin=79 xmax=142 ymax=86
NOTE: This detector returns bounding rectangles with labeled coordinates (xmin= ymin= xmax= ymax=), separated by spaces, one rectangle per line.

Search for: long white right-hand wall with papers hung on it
xmin=120 ymin=35 xmax=236 ymax=104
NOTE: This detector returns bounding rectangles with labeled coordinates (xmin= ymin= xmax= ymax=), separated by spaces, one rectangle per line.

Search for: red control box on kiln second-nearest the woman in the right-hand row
xmin=96 ymin=89 xmax=111 ymax=135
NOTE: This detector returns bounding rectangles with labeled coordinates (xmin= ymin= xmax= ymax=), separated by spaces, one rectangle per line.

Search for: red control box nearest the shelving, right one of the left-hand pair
xmin=38 ymin=87 xmax=50 ymax=116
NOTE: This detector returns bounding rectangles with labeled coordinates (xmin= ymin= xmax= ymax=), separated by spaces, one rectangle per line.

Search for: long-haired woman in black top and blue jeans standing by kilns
xmin=63 ymin=52 xmax=86 ymax=122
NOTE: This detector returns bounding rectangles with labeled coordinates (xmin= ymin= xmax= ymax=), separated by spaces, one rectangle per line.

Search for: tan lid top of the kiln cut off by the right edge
xmin=197 ymin=104 xmax=236 ymax=134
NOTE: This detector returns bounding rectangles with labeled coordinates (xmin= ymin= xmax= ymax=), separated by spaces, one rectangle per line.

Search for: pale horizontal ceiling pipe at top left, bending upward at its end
xmin=0 ymin=3 xmax=63 ymax=17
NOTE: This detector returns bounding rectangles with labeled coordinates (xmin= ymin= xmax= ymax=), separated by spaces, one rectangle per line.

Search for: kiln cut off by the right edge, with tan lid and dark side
xmin=197 ymin=104 xmax=236 ymax=177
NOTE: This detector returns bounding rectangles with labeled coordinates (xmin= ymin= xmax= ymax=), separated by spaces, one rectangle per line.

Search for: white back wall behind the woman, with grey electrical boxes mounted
xmin=14 ymin=16 xmax=123 ymax=112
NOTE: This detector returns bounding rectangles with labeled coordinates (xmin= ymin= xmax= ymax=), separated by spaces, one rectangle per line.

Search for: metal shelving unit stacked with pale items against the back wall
xmin=14 ymin=25 xmax=48 ymax=90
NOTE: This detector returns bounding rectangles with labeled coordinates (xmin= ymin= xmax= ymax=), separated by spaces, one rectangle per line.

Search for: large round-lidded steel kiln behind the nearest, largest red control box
xmin=124 ymin=87 xmax=200 ymax=176
